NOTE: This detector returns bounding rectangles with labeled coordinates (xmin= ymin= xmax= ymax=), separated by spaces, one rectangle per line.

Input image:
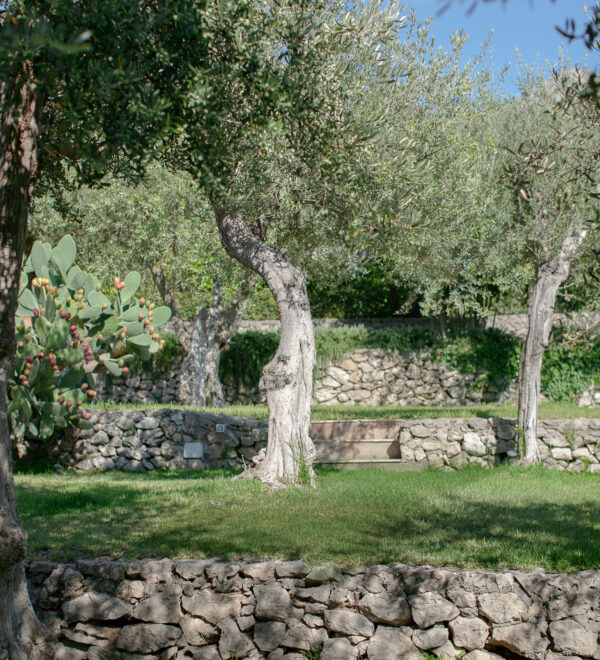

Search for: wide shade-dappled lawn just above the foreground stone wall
xmin=15 ymin=467 xmax=600 ymax=572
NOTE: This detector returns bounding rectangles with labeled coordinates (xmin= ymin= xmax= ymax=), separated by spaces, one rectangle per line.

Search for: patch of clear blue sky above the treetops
xmin=406 ymin=0 xmax=597 ymax=93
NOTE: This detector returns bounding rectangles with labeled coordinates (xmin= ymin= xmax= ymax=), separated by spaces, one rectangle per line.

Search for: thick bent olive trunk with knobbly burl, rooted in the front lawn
xmin=215 ymin=211 xmax=316 ymax=486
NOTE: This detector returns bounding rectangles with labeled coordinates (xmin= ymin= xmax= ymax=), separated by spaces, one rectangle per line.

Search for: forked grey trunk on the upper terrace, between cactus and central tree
xmin=152 ymin=266 xmax=250 ymax=408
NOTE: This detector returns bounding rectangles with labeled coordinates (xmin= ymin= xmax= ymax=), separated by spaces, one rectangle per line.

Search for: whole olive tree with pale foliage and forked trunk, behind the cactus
xmin=30 ymin=166 xmax=253 ymax=406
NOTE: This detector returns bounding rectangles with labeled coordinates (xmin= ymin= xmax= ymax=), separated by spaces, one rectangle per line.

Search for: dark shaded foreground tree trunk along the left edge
xmin=0 ymin=63 xmax=54 ymax=660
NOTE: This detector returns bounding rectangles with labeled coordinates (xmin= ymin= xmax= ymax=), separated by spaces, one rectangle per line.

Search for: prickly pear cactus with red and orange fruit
xmin=8 ymin=235 xmax=171 ymax=439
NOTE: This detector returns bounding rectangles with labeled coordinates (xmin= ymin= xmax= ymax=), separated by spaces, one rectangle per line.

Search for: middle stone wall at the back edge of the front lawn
xmin=24 ymin=409 xmax=600 ymax=472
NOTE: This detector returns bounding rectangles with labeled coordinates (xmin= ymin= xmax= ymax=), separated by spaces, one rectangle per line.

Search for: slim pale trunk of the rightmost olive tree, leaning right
xmin=518 ymin=219 xmax=587 ymax=464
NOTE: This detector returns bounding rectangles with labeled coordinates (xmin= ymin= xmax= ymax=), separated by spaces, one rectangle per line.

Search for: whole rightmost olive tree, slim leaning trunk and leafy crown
xmin=505 ymin=69 xmax=600 ymax=463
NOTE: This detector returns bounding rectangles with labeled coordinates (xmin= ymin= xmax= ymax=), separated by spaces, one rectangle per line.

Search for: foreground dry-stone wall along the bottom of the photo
xmin=25 ymin=559 xmax=600 ymax=660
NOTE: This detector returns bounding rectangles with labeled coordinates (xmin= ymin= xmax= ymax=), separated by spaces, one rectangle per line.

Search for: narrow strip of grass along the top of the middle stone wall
xmin=90 ymin=401 xmax=600 ymax=420
